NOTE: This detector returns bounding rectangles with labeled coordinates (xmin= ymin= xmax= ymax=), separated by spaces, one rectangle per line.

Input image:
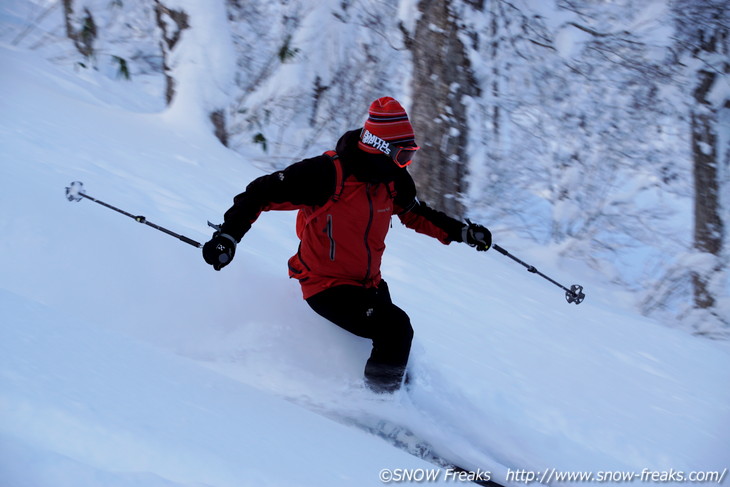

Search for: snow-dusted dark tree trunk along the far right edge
xmin=673 ymin=0 xmax=730 ymax=334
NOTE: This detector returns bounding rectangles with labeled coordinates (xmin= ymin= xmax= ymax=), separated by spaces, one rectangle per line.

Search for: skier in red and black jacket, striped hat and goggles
xmin=203 ymin=97 xmax=492 ymax=393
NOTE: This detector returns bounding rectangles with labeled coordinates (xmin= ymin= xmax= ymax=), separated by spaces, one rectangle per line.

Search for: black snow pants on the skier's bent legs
xmin=307 ymin=281 xmax=413 ymax=393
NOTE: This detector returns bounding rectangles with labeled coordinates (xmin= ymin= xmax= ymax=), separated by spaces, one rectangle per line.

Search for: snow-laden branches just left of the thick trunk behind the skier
xmin=223 ymin=0 xmax=410 ymax=167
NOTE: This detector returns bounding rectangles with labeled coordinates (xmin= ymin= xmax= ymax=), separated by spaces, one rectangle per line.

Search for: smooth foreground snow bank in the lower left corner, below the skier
xmin=0 ymin=291 xmax=460 ymax=486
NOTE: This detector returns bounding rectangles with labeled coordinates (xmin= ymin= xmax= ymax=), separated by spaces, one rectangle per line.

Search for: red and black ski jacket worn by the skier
xmin=222 ymin=131 xmax=464 ymax=299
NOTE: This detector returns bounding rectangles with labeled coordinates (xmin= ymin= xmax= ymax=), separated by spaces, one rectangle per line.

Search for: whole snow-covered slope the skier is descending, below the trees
xmin=0 ymin=27 xmax=730 ymax=487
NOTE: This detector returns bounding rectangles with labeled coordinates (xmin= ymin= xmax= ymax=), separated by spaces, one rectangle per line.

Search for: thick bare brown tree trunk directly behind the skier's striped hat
xmin=411 ymin=0 xmax=479 ymax=217
